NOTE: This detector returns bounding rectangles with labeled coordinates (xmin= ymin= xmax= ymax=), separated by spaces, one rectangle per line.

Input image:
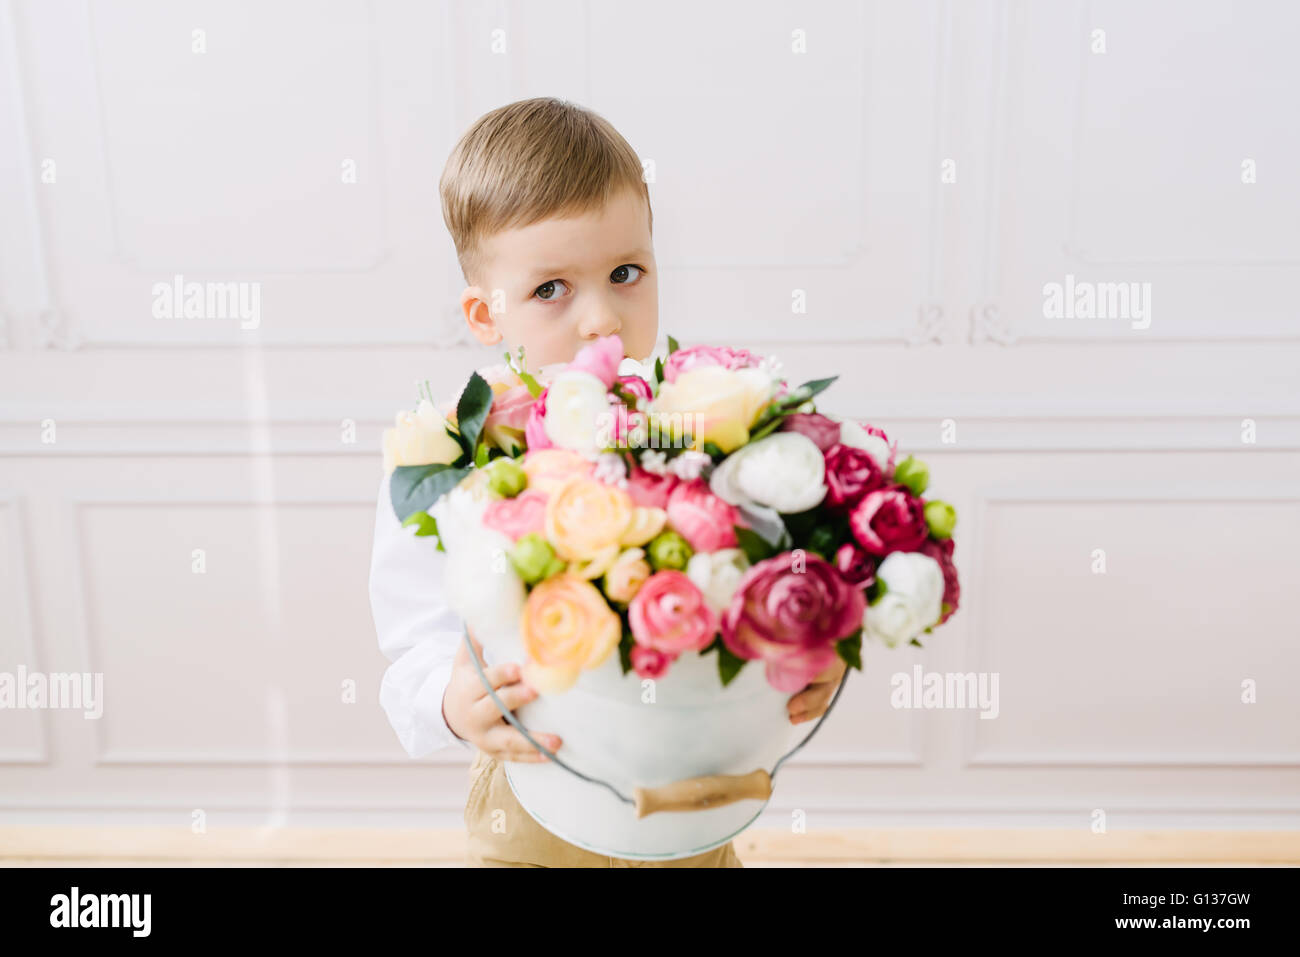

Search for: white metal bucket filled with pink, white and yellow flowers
xmin=384 ymin=337 xmax=959 ymax=859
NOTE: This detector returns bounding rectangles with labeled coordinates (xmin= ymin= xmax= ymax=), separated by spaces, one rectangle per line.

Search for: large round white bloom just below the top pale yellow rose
xmin=709 ymin=432 xmax=826 ymax=515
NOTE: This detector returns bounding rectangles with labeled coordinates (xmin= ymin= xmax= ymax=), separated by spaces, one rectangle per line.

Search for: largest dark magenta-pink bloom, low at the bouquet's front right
xmin=722 ymin=551 xmax=867 ymax=693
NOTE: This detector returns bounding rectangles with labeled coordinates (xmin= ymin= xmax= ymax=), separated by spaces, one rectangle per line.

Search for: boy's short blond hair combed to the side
xmin=438 ymin=96 xmax=654 ymax=282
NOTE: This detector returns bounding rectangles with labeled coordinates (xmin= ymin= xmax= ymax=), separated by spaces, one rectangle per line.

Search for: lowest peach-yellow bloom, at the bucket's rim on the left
xmin=520 ymin=575 xmax=623 ymax=694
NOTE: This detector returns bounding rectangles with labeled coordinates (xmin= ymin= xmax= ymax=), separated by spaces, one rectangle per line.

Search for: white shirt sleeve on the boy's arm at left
xmin=371 ymin=476 xmax=473 ymax=758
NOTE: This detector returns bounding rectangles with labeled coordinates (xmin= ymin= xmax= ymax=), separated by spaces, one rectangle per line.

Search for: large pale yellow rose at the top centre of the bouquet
xmin=650 ymin=365 xmax=772 ymax=452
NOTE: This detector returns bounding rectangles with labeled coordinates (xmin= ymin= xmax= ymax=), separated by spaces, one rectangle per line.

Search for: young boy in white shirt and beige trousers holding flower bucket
xmin=371 ymin=98 xmax=844 ymax=867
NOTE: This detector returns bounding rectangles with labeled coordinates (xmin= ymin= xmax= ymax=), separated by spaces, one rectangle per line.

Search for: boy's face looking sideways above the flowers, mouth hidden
xmin=460 ymin=190 xmax=659 ymax=369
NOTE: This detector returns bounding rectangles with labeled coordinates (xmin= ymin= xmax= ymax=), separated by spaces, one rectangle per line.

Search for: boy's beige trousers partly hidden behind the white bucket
xmin=465 ymin=750 xmax=745 ymax=867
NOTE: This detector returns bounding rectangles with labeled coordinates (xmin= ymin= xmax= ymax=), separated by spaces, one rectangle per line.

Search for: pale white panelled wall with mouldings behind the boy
xmin=0 ymin=0 xmax=1300 ymax=827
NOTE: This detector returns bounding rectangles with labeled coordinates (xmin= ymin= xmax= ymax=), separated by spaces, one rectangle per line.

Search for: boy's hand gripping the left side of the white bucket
xmin=442 ymin=632 xmax=560 ymax=762
